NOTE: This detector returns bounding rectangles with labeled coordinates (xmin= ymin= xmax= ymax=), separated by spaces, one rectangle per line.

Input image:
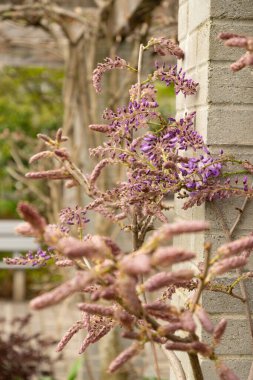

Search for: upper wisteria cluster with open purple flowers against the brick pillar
xmin=22 ymin=38 xmax=253 ymax=226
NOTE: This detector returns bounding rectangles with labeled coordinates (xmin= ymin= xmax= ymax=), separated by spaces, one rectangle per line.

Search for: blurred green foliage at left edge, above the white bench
xmin=0 ymin=67 xmax=63 ymax=218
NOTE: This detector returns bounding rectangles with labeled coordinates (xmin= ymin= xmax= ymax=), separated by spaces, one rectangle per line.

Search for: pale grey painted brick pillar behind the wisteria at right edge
xmin=176 ymin=0 xmax=253 ymax=380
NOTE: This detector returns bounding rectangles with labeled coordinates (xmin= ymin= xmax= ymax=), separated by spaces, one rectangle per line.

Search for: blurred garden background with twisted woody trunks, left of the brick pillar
xmin=0 ymin=0 xmax=178 ymax=380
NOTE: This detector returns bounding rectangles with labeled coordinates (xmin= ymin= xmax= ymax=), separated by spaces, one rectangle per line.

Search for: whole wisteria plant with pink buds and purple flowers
xmin=6 ymin=37 xmax=253 ymax=380
